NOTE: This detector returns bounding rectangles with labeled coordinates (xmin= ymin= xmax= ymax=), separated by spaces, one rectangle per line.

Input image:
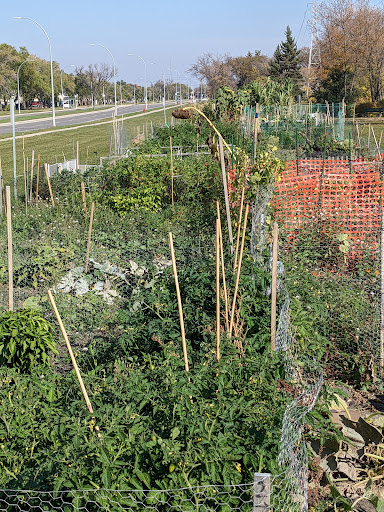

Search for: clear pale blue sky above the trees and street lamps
xmin=0 ymin=0 xmax=310 ymax=84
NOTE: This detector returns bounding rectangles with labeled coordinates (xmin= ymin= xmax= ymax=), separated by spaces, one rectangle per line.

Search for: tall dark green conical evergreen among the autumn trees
xmin=269 ymin=27 xmax=303 ymax=94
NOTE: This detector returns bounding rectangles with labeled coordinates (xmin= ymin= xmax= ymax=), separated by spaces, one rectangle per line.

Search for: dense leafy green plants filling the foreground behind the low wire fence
xmin=0 ymin=344 xmax=287 ymax=490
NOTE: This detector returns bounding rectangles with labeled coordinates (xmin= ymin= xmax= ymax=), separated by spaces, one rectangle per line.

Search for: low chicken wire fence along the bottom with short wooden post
xmin=0 ymin=473 xmax=301 ymax=512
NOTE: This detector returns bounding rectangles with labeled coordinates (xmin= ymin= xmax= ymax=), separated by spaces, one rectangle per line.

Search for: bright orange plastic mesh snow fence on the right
xmin=273 ymin=157 xmax=384 ymax=253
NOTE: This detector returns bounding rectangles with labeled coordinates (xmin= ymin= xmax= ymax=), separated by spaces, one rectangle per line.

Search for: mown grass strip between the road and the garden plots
xmin=0 ymin=107 xmax=174 ymax=186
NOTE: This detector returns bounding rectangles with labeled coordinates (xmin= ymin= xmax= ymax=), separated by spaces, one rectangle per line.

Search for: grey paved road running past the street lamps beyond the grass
xmin=0 ymin=103 xmax=172 ymax=135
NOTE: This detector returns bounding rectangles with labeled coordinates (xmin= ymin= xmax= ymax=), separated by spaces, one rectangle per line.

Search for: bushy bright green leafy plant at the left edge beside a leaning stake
xmin=0 ymin=309 xmax=57 ymax=372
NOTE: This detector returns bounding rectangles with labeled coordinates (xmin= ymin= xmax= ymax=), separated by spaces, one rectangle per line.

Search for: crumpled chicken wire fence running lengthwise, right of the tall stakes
xmin=251 ymin=181 xmax=323 ymax=512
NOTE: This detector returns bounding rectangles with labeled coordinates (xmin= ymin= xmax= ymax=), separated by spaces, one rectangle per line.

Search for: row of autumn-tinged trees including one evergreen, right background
xmin=190 ymin=0 xmax=384 ymax=104
